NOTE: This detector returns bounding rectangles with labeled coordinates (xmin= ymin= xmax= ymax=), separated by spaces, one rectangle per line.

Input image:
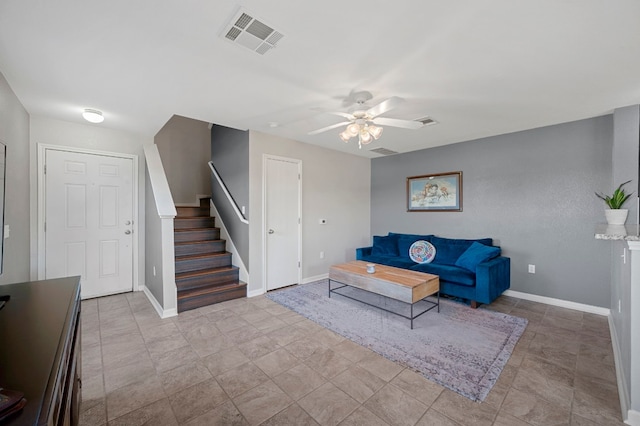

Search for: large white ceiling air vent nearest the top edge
xmin=221 ymin=9 xmax=284 ymax=55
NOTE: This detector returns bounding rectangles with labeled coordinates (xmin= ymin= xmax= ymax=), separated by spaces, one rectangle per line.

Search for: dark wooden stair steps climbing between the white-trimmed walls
xmin=173 ymin=198 xmax=247 ymax=312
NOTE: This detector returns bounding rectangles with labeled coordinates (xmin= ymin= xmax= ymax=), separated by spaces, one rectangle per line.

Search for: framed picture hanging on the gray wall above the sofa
xmin=407 ymin=171 xmax=462 ymax=212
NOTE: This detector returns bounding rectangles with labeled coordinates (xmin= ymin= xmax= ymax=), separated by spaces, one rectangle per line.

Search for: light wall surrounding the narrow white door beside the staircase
xmin=249 ymin=131 xmax=371 ymax=292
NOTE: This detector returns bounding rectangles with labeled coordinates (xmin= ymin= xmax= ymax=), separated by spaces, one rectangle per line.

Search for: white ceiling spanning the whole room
xmin=0 ymin=0 xmax=640 ymax=157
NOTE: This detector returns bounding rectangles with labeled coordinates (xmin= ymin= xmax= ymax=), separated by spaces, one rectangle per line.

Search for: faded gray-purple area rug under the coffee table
xmin=267 ymin=280 xmax=527 ymax=401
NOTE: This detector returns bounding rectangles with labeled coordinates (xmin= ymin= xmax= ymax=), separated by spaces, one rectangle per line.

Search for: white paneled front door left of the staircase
xmin=45 ymin=149 xmax=134 ymax=299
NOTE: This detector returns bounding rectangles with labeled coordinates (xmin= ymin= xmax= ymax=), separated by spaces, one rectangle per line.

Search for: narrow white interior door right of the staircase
xmin=264 ymin=157 xmax=301 ymax=290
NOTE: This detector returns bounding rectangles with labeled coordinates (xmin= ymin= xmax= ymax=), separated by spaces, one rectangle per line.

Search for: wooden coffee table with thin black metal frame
xmin=329 ymin=260 xmax=440 ymax=329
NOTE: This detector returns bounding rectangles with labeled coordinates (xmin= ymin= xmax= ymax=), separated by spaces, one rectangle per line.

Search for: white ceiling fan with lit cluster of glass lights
xmin=308 ymin=92 xmax=424 ymax=149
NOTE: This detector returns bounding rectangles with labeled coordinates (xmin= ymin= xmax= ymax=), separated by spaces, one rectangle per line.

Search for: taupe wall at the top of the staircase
xmin=154 ymin=115 xmax=211 ymax=204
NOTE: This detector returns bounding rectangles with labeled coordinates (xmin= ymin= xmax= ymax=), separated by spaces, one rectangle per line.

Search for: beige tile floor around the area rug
xmin=80 ymin=293 xmax=622 ymax=426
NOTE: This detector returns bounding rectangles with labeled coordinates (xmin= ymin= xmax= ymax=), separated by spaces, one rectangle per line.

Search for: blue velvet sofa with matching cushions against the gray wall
xmin=356 ymin=232 xmax=511 ymax=308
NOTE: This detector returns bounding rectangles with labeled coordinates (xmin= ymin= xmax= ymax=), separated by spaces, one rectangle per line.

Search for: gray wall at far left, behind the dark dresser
xmin=0 ymin=73 xmax=30 ymax=284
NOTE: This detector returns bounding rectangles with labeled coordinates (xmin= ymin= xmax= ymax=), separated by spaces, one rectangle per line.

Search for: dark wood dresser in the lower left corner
xmin=0 ymin=277 xmax=81 ymax=426
